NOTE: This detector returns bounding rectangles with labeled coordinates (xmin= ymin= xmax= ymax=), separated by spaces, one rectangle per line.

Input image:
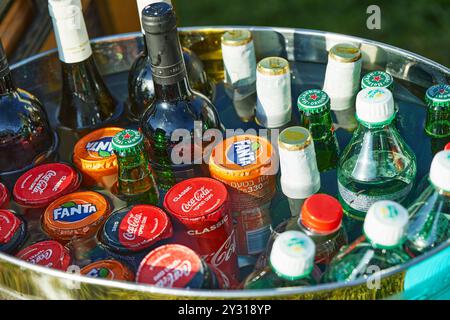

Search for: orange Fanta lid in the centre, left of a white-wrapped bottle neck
xmin=209 ymin=135 xmax=276 ymax=181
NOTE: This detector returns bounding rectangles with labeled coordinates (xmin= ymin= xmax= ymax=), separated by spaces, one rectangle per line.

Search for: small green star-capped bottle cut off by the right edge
xmin=425 ymin=84 xmax=450 ymax=138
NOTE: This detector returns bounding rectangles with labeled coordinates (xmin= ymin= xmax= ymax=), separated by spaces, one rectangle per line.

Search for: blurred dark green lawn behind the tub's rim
xmin=174 ymin=0 xmax=450 ymax=67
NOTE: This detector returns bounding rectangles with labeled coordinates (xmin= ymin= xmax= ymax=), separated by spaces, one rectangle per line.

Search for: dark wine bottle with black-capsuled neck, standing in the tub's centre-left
xmin=141 ymin=2 xmax=221 ymax=191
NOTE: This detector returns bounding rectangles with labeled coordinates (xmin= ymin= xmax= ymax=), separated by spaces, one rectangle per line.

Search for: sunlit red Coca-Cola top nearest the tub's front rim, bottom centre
xmin=136 ymin=244 xmax=206 ymax=289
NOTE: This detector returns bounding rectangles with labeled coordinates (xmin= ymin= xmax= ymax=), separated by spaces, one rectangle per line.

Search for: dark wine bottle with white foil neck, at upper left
xmin=48 ymin=0 xmax=122 ymax=132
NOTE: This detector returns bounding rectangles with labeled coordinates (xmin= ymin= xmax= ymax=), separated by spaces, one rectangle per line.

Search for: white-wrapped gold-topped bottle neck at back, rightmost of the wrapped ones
xmin=323 ymin=44 xmax=362 ymax=111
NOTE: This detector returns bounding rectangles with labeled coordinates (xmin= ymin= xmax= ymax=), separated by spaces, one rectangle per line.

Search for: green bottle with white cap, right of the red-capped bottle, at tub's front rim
xmin=322 ymin=201 xmax=410 ymax=282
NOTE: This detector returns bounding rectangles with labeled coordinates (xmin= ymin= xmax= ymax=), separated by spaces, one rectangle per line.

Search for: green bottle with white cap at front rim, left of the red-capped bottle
xmin=244 ymin=231 xmax=317 ymax=289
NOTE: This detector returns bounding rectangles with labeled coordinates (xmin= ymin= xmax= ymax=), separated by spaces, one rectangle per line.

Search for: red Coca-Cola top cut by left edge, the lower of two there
xmin=0 ymin=210 xmax=27 ymax=253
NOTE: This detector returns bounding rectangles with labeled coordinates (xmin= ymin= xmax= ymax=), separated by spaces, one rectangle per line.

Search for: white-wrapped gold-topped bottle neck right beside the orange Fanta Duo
xmin=278 ymin=127 xmax=320 ymax=199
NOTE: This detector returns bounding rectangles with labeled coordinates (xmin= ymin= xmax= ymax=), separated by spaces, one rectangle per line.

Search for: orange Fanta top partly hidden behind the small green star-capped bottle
xmin=73 ymin=128 xmax=124 ymax=186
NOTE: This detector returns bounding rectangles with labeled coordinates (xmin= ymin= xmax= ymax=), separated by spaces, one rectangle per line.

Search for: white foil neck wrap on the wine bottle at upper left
xmin=48 ymin=0 xmax=92 ymax=63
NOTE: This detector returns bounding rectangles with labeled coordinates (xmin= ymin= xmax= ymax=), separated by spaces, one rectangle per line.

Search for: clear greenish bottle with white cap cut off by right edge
xmin=406 ymin=151 xmax=450 ymax=256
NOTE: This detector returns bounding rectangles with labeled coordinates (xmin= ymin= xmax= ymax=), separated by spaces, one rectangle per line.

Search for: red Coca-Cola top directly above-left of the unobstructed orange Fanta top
xmin=13 ymin=163 xmax=82 ymax=208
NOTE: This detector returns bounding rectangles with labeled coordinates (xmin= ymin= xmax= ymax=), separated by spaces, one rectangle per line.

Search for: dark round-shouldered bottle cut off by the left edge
xmin=0 ymin=40 xmax=58 ymax=184
